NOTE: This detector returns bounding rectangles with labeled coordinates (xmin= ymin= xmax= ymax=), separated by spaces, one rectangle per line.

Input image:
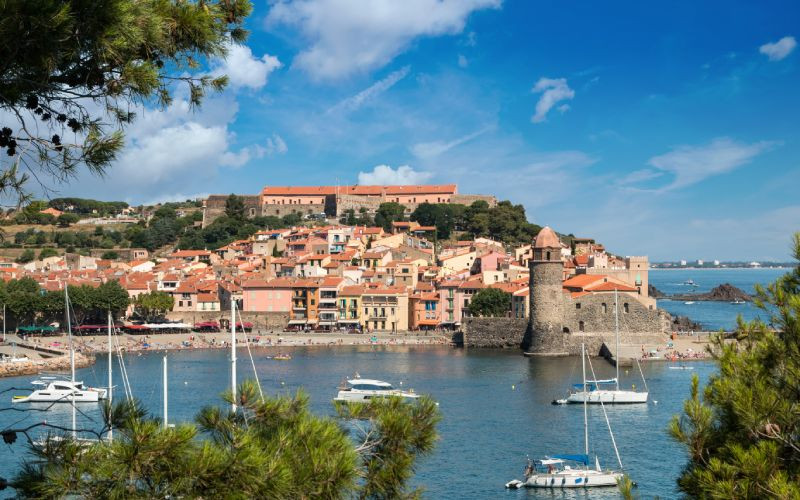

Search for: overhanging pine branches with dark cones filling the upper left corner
xmin=0 ymin=0 xmax=252 ymax=205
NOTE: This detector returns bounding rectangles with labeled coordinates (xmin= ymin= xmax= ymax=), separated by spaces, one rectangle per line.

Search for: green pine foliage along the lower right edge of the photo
xmin=669 ymin=233 xmax=800 ymax=499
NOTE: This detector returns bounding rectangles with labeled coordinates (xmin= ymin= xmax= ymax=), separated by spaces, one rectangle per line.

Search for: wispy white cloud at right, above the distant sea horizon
xmin=647 ymin=137 xmax=775 ymax=190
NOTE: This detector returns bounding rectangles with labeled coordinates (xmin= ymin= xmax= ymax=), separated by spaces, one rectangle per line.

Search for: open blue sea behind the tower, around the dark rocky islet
xmin=650 ymin=269 xmax=789 ymax=330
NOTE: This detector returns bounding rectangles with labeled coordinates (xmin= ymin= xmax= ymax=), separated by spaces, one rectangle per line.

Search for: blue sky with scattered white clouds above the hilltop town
xmin=62 ymin=0 xmax=800 ymax=260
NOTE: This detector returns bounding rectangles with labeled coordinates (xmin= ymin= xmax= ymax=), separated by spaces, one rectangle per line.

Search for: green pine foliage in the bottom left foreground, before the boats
xmin=12 ymin=381 xmax=440 ymax=499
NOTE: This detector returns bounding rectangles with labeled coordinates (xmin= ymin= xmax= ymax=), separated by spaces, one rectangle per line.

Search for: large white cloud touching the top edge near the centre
xmin=267 ymin=0 xmax=502 ymax=80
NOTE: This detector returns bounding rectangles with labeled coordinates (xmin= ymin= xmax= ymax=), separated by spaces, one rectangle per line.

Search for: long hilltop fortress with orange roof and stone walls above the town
xmin=203 ymin=184 xmax=497 ymax=227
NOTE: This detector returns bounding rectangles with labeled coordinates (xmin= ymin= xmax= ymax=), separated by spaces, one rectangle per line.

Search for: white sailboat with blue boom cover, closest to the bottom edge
xmin=506 ymin=344 xmax=623 ymax=488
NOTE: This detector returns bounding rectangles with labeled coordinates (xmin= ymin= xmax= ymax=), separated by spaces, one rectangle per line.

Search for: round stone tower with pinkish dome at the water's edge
xmin=522 ymin=227 xmax=564 ymax=351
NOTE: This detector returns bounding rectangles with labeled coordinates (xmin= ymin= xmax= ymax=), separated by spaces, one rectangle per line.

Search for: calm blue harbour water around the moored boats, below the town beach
xmin=0 ymin=346 xmax=714 ymax=498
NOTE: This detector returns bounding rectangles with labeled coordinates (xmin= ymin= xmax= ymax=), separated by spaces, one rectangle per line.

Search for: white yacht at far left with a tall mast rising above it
xmin=11 ymin=286 xmax=108 ymax=403
